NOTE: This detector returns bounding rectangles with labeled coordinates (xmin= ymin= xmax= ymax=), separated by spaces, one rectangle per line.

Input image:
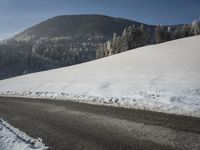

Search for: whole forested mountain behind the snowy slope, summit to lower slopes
xmin=0 ymin=15 xmax=154 ymax=79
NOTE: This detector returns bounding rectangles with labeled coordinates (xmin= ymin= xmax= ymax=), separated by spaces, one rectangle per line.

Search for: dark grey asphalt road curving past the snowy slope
xmin=0 ymin=97 xmax=200 ymax=150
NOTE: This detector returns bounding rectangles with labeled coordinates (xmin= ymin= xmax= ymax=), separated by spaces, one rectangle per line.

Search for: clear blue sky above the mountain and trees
xmin=0 ymin=0 xmax=200 ymax=39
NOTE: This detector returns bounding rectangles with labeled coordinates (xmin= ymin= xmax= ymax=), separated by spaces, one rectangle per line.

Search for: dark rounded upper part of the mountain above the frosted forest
xmin=14 ymin=15 xmax=150 ymax=41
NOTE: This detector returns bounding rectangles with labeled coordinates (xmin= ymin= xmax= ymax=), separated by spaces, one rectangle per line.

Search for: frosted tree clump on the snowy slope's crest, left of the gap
xmin=96 ymin=25 xmax=150 ymax=58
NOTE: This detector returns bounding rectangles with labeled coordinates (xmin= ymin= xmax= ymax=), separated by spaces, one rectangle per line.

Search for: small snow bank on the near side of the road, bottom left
xmin=0 ymin=119 xmax=48 ymax=150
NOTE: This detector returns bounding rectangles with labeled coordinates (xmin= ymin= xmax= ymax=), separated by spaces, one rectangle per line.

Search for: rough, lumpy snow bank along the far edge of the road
xmin=0 ymin=89 xmax=200 ymax=117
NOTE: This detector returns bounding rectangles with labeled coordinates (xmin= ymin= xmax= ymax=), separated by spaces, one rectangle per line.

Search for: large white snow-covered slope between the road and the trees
xmin=0 ymin=36 xmax=200 ymax=117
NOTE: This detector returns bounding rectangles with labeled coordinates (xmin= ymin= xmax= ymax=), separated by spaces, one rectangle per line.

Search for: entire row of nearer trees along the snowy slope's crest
xmin=96 ymin=20 xmax=200 ymax=58
